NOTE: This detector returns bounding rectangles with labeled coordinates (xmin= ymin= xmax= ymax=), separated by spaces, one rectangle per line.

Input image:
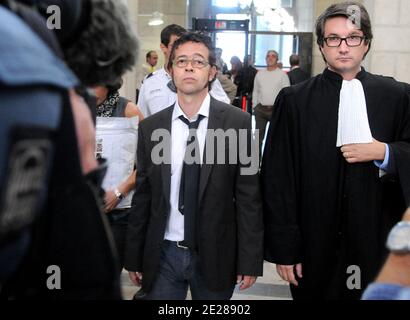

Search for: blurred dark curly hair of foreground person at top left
xmin=64 ymin=0 xmax=138 ymax=86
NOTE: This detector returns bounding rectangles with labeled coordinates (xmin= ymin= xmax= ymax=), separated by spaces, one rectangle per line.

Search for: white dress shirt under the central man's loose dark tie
xmin=164 ymin=94 xmax=211 ymax=241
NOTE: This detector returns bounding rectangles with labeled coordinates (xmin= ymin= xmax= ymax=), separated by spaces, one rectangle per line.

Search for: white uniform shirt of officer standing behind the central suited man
xmin=137 ymin=68 xmax=230 ymax=117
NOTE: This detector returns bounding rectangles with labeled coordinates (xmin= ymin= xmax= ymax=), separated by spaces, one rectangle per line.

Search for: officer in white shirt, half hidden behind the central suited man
xmin=137 ymin=24 xmax=230 ymax=117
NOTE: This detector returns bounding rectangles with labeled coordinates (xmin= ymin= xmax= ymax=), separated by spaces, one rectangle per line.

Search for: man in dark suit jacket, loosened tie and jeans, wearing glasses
xmin=125 ymin=33 xmax=263 ymax=300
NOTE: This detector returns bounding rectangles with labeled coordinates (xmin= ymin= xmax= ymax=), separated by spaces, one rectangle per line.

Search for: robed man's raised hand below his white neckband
xmin=341 ymin=139 xmax=386 ymax=163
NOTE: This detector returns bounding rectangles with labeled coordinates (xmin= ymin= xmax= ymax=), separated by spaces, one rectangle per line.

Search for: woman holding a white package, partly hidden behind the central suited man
xmin=94 ymin=81 xmax=144 ymax=269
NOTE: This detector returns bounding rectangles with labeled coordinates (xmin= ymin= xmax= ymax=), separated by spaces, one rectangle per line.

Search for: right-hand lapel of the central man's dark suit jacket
xmin=198 ymin=97 xmax=224 ymax=205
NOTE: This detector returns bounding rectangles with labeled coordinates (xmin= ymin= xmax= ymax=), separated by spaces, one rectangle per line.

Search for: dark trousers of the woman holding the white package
xmin=107 ymin=209 xmax=130 ymax=271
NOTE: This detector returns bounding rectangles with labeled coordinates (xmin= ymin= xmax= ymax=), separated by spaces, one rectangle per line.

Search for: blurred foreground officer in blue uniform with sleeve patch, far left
xmin=0 ymin=1 xmax=77 ymax=284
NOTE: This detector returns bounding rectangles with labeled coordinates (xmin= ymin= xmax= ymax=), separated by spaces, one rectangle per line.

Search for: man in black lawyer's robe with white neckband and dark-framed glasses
xmin=261 ymin=2 xmax=410 ymax=299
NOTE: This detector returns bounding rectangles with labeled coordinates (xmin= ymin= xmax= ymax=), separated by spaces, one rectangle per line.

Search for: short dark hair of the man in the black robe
xmin=316 ymin=1 xmax=373 ymax=50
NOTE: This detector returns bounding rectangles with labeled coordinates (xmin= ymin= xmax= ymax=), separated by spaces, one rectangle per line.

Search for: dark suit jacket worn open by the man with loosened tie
xmin=125 ymin=98 xmax=263 ymax=292
